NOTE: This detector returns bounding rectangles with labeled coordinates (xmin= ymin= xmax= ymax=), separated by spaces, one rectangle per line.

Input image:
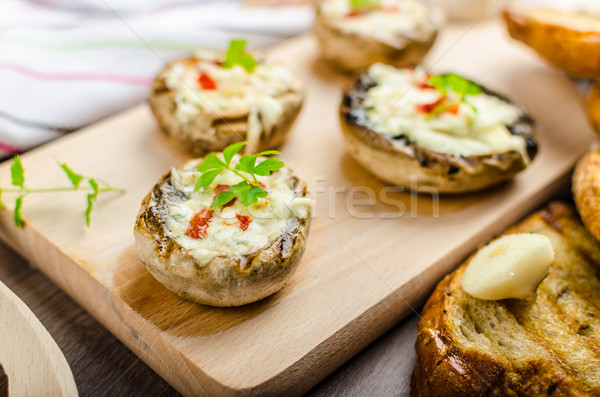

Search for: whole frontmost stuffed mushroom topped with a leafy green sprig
xmin=134 ymin=148 xmax=312 ymax=306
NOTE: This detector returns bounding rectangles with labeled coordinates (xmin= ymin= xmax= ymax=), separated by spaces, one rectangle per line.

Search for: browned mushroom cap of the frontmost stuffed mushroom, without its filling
xmin=134 ymin=160 xmax=310 ymax=307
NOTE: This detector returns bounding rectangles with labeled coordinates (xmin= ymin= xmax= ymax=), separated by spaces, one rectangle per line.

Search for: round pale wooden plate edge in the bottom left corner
xmin=0 ymin=282 xmax=78 ymax=397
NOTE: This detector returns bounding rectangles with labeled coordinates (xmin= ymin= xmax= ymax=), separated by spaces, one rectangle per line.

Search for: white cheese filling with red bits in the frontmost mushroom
xmin=164 ymin=159 xmax=313 ymax=264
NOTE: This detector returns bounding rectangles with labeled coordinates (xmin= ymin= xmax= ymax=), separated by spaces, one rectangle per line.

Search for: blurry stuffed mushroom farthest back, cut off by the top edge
xmin=314 ymin=0 xmax=442 ymax=73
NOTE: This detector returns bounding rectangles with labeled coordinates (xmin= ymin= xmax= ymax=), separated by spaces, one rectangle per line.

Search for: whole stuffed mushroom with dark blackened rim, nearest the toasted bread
xmin=340 ymin=64 xmax=537 ymax=193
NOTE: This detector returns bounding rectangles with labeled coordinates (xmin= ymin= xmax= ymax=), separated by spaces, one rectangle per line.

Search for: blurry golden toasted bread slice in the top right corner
xmin=504 ymin=5 xmax=600 ymax=78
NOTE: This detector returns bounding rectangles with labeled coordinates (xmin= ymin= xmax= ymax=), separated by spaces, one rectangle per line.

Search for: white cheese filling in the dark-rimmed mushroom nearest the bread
xmin=363 ymin=64 xmax=529 ymax=160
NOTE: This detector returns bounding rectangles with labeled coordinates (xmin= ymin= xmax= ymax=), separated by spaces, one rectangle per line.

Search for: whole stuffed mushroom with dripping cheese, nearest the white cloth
xmin=150 ymin=40 xmax=304 ymax=156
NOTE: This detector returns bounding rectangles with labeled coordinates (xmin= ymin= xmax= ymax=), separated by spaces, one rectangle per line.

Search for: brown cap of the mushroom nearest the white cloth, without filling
xmin=149 ymin=58 xmax=304 ymax=156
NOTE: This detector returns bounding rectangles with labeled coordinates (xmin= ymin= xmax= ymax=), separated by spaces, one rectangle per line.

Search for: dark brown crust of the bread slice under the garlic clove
xmin=411 ymin=203 xmax=600 ymax=397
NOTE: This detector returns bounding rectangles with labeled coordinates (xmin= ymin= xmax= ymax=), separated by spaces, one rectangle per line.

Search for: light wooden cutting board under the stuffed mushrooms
xmin=0 ymin=22 xmax=594 ymax=395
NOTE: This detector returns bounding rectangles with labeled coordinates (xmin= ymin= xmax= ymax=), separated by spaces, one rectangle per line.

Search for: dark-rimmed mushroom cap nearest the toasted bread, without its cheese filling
xmin=339 ymin=73 xmax=537 ymax=194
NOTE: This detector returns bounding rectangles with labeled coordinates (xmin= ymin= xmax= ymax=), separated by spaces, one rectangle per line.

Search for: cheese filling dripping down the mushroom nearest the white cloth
xmin=165 ymin=52 xmax=301 ymax=153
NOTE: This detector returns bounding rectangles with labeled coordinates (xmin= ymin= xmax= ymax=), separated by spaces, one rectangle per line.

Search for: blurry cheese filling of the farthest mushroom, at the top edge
xmin=321 ymin=0 xmax=441 ymax=45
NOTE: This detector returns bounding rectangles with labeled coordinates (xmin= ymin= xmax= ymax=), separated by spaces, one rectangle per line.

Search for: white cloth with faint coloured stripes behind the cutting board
xmin=0 ymin=0 xmax=312 ymax=157
